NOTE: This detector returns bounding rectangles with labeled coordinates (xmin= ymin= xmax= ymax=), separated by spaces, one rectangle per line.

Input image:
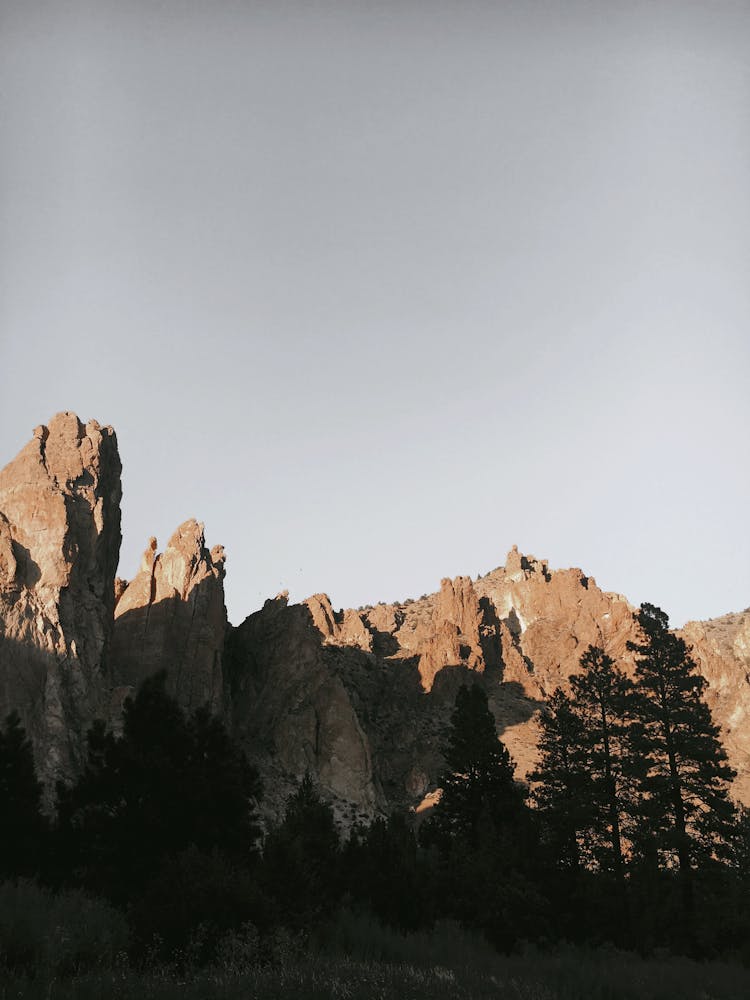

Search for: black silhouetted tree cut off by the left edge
xmin=0 ymin=712 xmax=47 ymax=878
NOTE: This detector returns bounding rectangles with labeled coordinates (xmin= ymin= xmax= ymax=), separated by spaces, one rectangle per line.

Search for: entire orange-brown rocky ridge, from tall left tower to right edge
xmin=0 ymin=413 xmax=750 ymax=822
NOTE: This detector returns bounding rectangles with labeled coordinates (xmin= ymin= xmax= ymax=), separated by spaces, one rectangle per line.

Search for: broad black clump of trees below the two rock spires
xmin=58 ymin=673 xmax=261 ymax=903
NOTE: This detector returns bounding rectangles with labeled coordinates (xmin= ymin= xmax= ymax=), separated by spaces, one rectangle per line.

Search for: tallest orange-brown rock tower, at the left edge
xmin=0 ymin=413 xmax=122 ymax=788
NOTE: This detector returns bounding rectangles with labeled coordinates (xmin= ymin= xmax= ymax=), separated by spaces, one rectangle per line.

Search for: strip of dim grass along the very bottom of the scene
xmin=0 ymin=948 xmax=750 ymax=1000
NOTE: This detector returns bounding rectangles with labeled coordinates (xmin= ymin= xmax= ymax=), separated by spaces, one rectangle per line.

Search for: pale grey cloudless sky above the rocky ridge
xmin=0 ymin=0 xmax=750 ymax=625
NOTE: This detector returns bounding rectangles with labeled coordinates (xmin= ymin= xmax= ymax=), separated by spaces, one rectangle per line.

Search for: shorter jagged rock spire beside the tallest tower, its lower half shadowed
xmin=110 ymin=520 xmax=227 ymax=715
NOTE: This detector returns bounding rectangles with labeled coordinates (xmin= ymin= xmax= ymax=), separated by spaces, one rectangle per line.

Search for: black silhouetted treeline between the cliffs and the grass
xmin=0 ymin=604 xmax=750 ymax=976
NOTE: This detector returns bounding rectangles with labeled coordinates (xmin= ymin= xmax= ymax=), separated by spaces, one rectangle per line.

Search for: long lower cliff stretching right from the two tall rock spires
xmin=229 ymin=548 xmax=750 ymax=816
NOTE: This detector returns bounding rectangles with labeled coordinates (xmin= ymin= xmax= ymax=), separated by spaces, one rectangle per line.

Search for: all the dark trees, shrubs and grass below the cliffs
xmin=0 ymin=605 xmax=750 ymax=1000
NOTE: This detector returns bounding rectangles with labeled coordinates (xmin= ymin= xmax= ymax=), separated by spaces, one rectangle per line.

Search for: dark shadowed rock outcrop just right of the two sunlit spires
xmin=227 ymin=595 xmax=377 ymax=821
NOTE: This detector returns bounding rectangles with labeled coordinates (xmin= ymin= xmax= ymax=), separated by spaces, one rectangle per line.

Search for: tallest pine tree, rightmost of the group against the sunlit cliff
xmin=628 ymin=604 xmax=734 ymax=935
